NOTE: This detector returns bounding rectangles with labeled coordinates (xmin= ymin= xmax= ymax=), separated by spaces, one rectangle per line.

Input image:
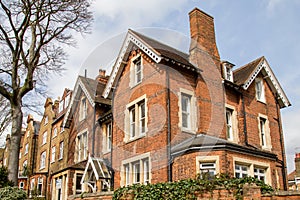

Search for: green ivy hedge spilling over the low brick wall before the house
xmin=113 ymin=174 xmax=273 ymax=200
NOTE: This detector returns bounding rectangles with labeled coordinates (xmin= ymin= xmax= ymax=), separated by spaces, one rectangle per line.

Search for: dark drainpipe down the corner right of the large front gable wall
xmin=166 ymin=68 xmax=172 ymax=182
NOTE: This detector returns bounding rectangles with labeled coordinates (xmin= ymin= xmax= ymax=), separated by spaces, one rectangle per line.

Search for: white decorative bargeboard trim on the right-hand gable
xmin=242 ymin=58 xmax=291 ymax=108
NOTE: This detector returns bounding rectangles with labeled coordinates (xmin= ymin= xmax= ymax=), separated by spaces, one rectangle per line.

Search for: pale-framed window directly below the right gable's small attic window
xmin=257 ymin=113 xmax=272 ymax=151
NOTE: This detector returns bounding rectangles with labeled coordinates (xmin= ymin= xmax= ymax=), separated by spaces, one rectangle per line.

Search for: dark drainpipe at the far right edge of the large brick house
xmin=276 ymin=102 xmax=288 ymax=191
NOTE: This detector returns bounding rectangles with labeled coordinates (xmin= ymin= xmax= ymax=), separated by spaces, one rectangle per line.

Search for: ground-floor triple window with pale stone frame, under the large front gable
xmin=121 ymin=152 xmax=151 ymax=186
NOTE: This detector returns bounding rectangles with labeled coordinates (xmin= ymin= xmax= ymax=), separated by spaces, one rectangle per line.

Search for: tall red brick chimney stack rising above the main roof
xmin=189 ymin=8 xmax=220 ymax=67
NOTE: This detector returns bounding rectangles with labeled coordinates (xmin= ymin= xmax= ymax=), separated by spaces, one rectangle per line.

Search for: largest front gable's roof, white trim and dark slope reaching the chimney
xmin=102 ymin=29 xmax=201 ymax=98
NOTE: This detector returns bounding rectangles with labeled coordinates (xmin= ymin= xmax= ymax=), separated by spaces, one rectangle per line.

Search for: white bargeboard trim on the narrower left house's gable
xmin=62 ymin=77 xmax=95 ymax=127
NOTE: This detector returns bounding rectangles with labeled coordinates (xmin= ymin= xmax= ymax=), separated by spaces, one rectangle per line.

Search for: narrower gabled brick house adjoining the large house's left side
xmin=61 ymin=70 xmax=111 ymax=196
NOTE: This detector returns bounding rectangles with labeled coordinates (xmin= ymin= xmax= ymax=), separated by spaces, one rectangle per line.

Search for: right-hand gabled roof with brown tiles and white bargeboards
xmin=233 ymin=56 xmax=291 ymax=108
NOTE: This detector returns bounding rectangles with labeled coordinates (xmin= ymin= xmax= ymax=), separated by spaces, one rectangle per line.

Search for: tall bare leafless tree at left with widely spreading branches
xmin=0 ymin=0 xmax=92 ymax=184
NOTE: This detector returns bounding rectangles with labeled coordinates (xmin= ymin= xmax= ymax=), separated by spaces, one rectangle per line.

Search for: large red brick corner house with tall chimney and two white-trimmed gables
xmin=103 ymin=8 xmax=290 ymax=189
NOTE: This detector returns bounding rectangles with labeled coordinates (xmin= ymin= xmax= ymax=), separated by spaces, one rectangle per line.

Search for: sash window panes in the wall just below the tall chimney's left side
xmin=181 ymin=94 xmax=192 ymax=129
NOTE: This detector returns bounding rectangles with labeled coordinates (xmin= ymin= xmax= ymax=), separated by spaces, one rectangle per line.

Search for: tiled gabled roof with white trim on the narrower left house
xmin=63 ymin=76 xmax=97 ymax=127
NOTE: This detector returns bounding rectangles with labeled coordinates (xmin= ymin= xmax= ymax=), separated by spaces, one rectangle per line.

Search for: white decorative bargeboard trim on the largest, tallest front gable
xmin=102 ymin=30 xmax=162 ymax=98
